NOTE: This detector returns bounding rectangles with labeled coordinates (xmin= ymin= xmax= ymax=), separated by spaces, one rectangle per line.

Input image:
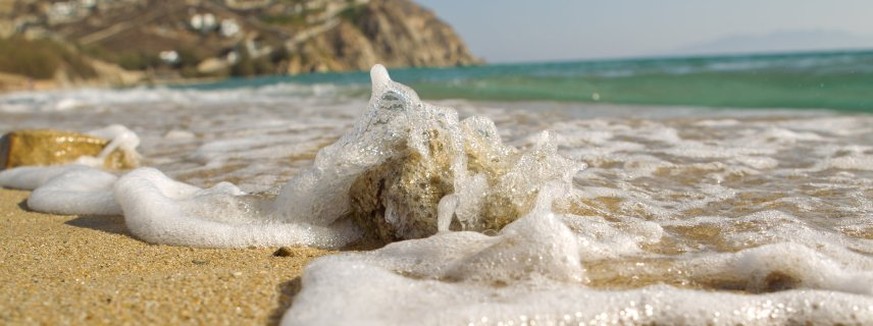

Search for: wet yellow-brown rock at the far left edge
xmin=0 ymin=129 xmax=137 ymax=170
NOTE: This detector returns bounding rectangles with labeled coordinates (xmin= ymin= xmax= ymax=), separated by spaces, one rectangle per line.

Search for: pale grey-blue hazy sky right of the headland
xmin=417 ymin=0 xmax=873 ymax=62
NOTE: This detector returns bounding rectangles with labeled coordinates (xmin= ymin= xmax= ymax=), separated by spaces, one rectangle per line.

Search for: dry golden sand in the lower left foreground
xmin=0 ymin=189 xmax=331 ymax=325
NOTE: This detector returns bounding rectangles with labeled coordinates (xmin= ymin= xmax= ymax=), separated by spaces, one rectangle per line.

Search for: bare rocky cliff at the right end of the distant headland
xmin=288 ymin=0 xmax=482 ymax=73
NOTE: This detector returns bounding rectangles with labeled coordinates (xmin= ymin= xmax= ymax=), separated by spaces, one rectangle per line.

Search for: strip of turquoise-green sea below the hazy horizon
xmin=185 ymin=51 xmax=873 ymax=112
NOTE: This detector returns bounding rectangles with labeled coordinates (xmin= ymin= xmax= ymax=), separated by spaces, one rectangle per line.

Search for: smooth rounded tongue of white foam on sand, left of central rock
xmin=115 ymin=168 xmax=359 ymax=248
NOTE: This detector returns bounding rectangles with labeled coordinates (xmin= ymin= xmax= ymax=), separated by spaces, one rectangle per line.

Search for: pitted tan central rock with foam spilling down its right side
xmin=349 ymin=117 xmax=580 ymax=244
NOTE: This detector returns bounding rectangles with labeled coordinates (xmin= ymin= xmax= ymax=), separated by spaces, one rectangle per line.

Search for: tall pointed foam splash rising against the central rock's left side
xmin=275 ymin=65 xmax=428 ymax=225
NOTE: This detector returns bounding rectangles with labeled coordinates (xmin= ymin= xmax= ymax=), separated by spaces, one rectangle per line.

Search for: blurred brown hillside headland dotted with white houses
xmin=0 ymin=0 xmax=481 ymax=90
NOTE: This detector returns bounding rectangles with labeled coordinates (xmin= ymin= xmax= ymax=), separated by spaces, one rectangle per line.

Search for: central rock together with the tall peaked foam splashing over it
xmin=276 ymin=65 xmax=584 ymax=242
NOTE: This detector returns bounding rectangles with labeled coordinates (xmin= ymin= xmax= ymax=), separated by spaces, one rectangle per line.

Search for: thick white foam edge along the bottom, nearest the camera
xmin=282 ymin=219 xmax=873 ymax=325
